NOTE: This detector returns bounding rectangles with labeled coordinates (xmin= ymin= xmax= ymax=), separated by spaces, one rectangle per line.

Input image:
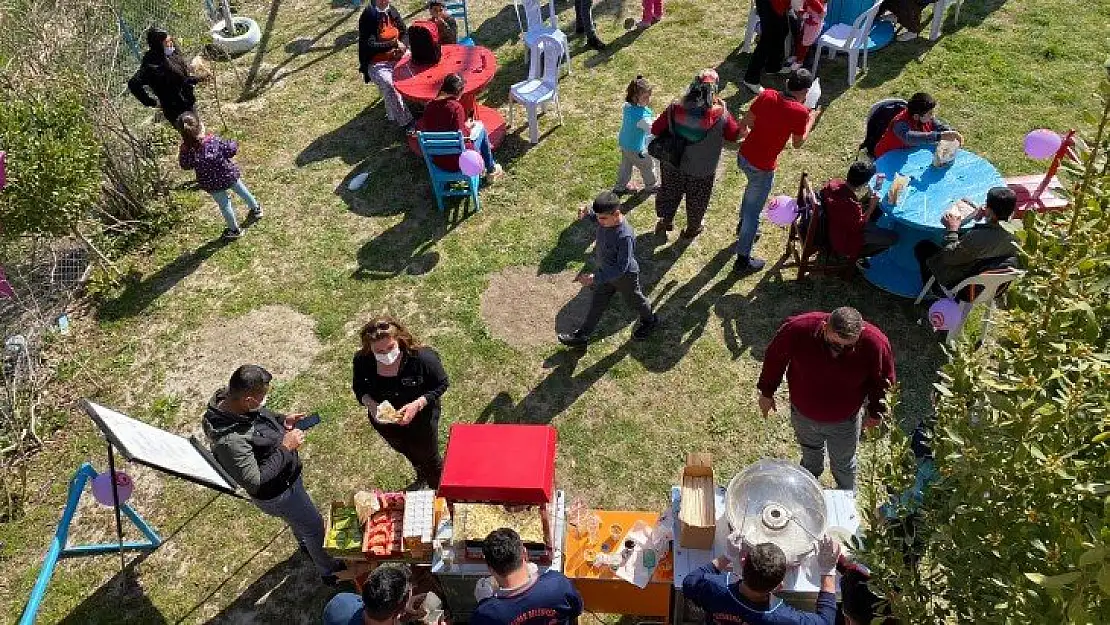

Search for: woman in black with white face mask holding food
xmin=351 ymin=316 xmax=450 ymax=488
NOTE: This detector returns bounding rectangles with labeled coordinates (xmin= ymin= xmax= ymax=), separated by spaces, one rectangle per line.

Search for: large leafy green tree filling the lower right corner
xmin=859 ymin=72 xmax=1110 ymax=624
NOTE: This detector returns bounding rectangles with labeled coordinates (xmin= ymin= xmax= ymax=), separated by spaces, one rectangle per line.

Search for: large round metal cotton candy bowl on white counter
xmin=725 ymin=460 xmax=828 ymax=565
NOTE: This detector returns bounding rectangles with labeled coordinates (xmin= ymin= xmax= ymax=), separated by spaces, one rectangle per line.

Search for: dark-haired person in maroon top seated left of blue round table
xmin=820 ymin=161 xmax=898 ymax=261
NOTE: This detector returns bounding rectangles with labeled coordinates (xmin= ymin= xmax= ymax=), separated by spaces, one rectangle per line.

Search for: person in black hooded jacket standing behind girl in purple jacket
xmin=128 ymin=28 xmax=199 ymax=125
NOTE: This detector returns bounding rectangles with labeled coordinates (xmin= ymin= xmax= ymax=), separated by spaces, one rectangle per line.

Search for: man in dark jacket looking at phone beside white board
xmin=203 ymin=364 xmax=346 ymax=585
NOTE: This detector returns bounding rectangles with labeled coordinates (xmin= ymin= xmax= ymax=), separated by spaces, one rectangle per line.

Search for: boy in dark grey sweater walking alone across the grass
xmin=558 ymin=191 xmax=659 ymax=347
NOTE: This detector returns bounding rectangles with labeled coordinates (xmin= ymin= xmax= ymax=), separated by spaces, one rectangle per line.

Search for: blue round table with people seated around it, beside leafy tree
xmin=864 ymin=147 xmax=1006 ymax=298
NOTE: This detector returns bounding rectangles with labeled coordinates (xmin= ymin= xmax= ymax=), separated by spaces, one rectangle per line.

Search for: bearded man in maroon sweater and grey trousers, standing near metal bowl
xmin=756 ymin=306 xmax=895 ymax=491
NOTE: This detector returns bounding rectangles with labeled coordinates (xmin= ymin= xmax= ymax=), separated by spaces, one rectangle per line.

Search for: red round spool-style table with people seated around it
xmin=393 ymin=44 xmax=505 ymax=154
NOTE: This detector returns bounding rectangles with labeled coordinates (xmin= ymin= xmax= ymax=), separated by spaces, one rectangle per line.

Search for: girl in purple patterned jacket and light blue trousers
xmin=178 ymin=112 xmax=262 ymax=239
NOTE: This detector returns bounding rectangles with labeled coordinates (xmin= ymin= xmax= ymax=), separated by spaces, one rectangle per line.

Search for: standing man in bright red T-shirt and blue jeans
xmin=734 ymin=69 xmax=817 ymax=272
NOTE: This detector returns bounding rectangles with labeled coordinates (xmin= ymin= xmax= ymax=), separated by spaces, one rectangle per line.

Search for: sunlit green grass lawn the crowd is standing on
xmin=0 ymin=0 xmax=1110 ymax=624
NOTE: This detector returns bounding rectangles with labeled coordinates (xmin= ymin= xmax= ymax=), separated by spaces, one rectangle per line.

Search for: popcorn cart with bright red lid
xmin=432 ymin=423 xmax=566 ymax=621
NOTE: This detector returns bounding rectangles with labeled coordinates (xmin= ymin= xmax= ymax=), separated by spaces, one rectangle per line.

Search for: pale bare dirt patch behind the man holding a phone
xmin=165 ymin=305 xmax=323 ymax=401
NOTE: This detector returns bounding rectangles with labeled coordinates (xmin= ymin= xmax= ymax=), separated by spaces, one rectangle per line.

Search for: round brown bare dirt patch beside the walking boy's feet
xmin=482 ymin=266 xmax=589 ymax=347
